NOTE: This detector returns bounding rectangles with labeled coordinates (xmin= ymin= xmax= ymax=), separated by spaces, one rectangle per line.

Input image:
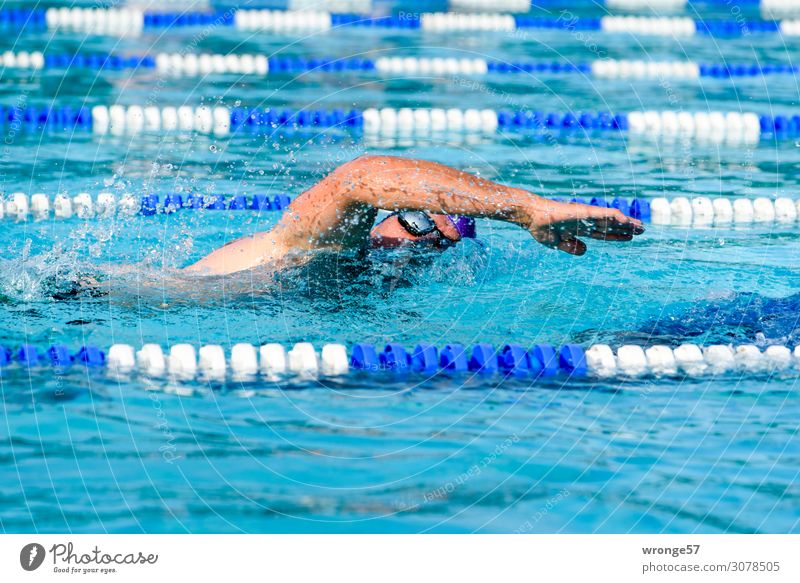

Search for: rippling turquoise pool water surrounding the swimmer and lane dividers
xmin=0 ymin=4 xmax=800 ymax=533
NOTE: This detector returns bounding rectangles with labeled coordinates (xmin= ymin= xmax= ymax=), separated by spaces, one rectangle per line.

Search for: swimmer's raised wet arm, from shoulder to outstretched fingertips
xmin=282 ymin=156 xmax=644 ymax=255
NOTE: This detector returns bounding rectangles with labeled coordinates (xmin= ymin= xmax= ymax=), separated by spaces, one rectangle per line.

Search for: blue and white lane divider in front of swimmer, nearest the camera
xmin=0 ymin=342 xmax=800 ymax=381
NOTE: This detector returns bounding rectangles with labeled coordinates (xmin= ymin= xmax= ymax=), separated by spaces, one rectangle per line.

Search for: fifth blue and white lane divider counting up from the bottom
xmin=0 ymin=7 xmax=800 ymax=37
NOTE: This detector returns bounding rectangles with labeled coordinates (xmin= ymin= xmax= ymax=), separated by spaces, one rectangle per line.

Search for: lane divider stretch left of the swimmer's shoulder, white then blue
xmin=0 ymin=192 xmax=292 ymax=221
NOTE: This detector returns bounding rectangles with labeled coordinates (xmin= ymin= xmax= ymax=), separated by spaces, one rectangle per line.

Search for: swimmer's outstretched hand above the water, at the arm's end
xmin=527 ymin=198 xmax=644 ymax=255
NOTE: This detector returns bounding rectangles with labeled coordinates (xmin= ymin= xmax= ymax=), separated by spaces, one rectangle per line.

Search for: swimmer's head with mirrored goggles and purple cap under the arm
xmin=370 ymin=211 xmax=475 ymax=249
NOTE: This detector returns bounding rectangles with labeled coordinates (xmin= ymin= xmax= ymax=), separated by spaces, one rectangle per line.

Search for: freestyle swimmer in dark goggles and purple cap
xmin=183 ymin=156 xmax=644 ymax=275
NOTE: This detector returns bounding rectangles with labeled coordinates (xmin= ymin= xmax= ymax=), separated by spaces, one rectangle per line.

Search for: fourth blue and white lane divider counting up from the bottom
xmin=0 ymin=51 xmax=800 ymax=79
